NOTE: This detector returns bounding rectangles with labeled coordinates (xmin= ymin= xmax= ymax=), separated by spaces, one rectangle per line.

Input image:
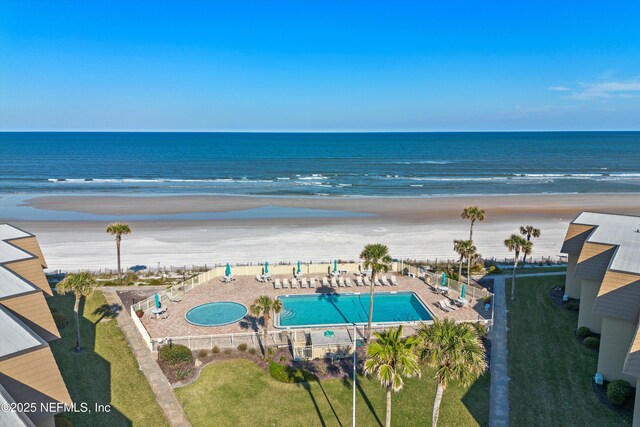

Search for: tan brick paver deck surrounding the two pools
xmin=142 ymin=274 xmax=491 ymax=339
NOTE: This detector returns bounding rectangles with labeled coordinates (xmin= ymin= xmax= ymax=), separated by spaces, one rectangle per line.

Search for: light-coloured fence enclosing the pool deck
xmin=130 ymin=261 xmax=493 ymax=358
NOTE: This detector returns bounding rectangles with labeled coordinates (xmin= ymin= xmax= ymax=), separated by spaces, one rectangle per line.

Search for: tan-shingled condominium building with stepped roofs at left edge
xmin=0 ymin=224 xmax=71 ymax=427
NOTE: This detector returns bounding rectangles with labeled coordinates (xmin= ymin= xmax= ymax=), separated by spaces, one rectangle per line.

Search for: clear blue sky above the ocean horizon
xmin=0 ymin=0 xmax=640 ymax=131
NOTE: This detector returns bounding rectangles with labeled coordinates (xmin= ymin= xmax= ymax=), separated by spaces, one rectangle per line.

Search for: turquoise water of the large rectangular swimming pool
xmin=278 ymin=292 xmax=432 ymax=327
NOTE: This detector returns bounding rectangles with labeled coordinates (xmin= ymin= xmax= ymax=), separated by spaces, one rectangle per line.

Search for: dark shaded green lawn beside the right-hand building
xmin=506 ymin=276 xmax=631 ymax=426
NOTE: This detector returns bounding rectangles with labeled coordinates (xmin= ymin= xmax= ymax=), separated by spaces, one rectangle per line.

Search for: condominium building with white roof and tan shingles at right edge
xmin=562 ymin=212 xmax=640 ymax=426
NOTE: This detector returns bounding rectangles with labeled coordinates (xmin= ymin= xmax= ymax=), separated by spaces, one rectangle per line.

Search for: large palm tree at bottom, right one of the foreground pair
xmin=418 ymin=319 xmax=487 ymax=427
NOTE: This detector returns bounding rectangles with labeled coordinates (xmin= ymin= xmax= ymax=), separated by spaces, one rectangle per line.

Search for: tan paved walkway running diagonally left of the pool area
xmin=101 ymin=288 xmax=191 ymax=427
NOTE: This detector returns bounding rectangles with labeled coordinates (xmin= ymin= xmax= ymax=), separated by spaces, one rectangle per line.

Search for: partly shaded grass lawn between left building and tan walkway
xmin=48 ymin=292 xmax=168 ymax=427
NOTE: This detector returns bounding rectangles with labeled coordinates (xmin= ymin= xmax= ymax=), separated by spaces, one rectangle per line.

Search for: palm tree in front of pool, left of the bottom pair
xmin=364 ymin=325 xmax=420 ymax=427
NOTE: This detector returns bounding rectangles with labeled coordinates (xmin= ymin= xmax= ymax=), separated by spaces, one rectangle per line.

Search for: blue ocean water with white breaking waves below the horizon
xmin=0 ymin=132 xmax=640 ymax=197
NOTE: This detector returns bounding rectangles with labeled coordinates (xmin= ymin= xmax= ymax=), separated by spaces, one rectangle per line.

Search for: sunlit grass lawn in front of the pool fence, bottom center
xmin=175 ymin=360 xmax=489 ymax=427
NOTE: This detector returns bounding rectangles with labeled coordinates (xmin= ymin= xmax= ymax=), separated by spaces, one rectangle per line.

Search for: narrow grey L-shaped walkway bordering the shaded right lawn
xmin=489 ymin=272 xmax=566 ymax=427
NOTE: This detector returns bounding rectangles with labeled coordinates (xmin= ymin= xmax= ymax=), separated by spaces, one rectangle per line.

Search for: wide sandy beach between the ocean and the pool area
xmin=2 ymin=194 xmax=640 ymax=269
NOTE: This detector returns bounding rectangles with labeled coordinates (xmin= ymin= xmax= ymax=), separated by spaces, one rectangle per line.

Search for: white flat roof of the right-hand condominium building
xmin=572 ymin=212 xmax=640 ymax=274
